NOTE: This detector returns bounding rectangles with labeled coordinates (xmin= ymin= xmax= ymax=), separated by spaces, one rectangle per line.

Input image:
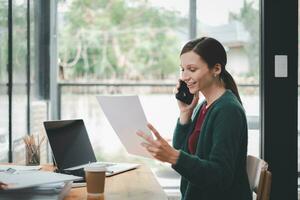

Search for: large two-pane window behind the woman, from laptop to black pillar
xmin=58 ymin=0 xmax=259 ymax=195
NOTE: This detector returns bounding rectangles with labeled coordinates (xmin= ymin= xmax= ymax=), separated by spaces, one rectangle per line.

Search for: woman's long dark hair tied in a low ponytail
xmin=180 ymin=37 xmax=242 ymax=104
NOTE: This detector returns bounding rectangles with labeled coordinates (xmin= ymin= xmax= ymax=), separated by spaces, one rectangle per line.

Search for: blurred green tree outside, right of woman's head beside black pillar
xmin=229 ymin=0 xmax=260 ymax=80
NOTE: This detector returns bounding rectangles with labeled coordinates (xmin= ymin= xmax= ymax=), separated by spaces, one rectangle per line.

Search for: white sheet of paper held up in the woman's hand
xmin=97 ymin=96 xmax=152 ymax=158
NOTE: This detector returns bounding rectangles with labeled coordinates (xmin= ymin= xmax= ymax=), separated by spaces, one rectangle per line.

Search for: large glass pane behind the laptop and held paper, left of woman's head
xmin=58 ymin=0 xmax=188 ymax=192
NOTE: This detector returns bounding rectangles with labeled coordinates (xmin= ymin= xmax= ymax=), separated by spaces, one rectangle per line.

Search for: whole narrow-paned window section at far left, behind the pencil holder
xmin=0 ymin=0 xmax=47 ymax=164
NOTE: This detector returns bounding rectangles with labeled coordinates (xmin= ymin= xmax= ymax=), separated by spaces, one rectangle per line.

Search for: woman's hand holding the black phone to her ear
xmin=174 ymin=80 xmax=199 ymax=124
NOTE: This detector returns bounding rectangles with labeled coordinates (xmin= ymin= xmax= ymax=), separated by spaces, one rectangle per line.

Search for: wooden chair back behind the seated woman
xmin=247 ymin=155 xmax=272 ymax=200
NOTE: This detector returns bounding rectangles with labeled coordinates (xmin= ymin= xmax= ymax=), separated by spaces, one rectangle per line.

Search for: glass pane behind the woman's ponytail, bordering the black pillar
xmin=197 ymin=0 xmax=260 ymax=156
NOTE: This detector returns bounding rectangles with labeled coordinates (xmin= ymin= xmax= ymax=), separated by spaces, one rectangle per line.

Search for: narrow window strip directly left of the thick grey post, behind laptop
xmin=27 ymin=0 xmax=50 ymax=163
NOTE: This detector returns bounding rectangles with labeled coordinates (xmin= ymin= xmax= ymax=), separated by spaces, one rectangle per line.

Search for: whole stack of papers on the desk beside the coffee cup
xmin=0 ymin=166 xmax=82 ymax=200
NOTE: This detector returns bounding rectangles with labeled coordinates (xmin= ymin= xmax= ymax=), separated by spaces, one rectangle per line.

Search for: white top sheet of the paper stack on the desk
xmin=0 ymin=171 xmax=82 ymax=190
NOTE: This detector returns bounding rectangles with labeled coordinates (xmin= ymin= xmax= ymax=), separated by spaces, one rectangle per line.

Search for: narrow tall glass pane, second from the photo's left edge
xmin=12 ymin=0 xmax=27 ymax=163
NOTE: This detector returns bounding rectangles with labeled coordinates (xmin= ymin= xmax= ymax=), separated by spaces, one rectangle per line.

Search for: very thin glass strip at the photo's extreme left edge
xmin=0 ymin=0 xmax=8 ymax=162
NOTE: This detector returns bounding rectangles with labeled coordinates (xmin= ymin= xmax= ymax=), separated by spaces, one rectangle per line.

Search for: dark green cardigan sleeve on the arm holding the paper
xmin=172 ymin=105 xmax=247 ymax=190
